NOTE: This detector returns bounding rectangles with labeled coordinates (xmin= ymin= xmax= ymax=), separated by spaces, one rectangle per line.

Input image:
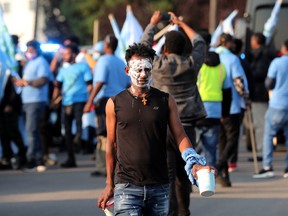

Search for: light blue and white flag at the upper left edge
xmin=0 ymin=6 xmax=17 ymax=74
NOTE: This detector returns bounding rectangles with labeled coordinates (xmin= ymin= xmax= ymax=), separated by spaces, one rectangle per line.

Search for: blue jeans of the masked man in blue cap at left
xmin=23 ymin=102 xmax=46 ymax=163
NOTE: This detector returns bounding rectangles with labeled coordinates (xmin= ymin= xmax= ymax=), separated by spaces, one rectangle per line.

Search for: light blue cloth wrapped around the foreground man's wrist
xmin=182 ymin=148 xmax=206 ymax=186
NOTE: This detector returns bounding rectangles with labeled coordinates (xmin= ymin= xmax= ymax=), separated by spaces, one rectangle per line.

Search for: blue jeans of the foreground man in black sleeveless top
xmin=114 ymin=183 xmax=169 ymax=216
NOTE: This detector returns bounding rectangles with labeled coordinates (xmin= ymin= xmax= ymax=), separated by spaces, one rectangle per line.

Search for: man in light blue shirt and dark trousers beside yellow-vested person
xmin=215 ymin=33 xmax=249 ymax=187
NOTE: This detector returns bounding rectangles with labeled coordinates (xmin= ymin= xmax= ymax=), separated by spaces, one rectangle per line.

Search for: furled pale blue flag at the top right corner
xmin=263 ymin=0 xmax=282 ymax=45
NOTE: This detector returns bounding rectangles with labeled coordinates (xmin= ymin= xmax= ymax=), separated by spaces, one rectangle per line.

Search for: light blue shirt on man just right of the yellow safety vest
xmin=215 ymin=47 xmax=248 ymax=114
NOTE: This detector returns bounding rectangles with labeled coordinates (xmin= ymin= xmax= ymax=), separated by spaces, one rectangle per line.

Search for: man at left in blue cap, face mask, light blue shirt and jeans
xmin=15 ymin=40 xmax=50 ymax=172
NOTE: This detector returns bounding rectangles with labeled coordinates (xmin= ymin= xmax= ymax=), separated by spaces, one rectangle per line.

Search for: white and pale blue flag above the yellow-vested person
xmin=210 ymin=10 xmax=238 ymax=47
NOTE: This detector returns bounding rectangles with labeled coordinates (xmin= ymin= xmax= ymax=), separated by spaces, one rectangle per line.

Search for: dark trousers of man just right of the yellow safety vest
xmin=218 ymin=114 xmax=242 ymax=169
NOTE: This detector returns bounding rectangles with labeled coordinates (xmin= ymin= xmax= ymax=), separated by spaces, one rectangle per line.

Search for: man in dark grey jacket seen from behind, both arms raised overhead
xmin=141 ymin=11 xmax=206 ymax=215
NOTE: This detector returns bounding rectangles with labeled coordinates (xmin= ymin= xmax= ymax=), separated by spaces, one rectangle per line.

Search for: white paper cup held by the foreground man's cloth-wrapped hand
xmin=197 ymin=169 xmax=215 ymax=197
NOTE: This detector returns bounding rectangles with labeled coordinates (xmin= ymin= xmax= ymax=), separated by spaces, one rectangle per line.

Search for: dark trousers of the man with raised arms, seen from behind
xmin=167 ymin=126 xmax=195 ymax=216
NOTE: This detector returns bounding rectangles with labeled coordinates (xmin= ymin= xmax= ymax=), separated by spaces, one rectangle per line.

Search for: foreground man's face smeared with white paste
xmin=127 ymin=56 xmax=152 ymax=88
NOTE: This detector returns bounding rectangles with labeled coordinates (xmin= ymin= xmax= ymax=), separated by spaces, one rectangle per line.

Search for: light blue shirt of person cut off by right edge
xmin=267 ymin=55 xmax=288 ymax=110
